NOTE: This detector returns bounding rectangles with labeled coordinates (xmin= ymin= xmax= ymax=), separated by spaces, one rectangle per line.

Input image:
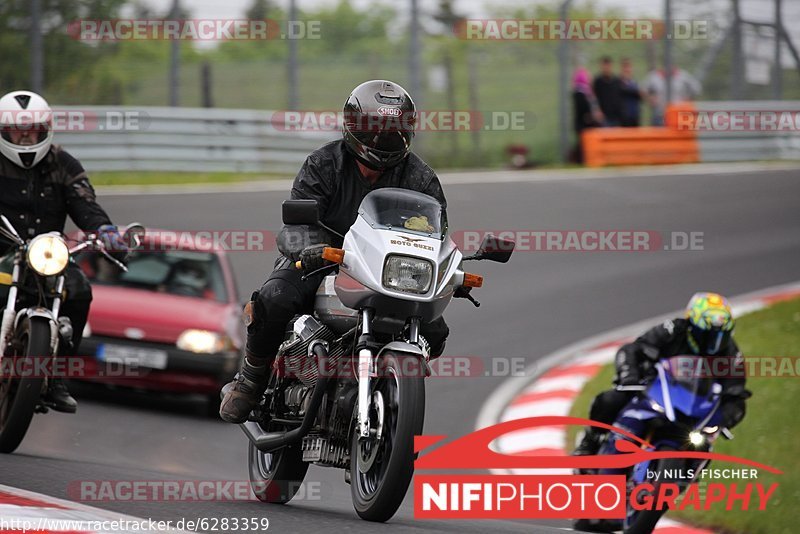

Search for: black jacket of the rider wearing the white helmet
xmin=0 ymin=141 xmax=111 ymax=253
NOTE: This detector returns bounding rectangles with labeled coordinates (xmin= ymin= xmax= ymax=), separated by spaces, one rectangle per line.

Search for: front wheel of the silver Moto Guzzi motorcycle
xmin=350 ymin=353 xmax=425 ymax=522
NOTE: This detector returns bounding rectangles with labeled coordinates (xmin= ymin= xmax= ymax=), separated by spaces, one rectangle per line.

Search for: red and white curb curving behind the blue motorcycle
xmin=476 ymin=282 xmax=800 ymax=534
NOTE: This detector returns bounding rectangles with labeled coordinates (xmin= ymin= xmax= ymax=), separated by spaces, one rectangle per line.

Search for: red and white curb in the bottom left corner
xmin=0 ymin=484 xmax=187 ymax=534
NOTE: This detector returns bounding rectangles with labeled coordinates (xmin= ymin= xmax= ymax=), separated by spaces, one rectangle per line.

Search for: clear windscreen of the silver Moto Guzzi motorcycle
xmin=358 ymin=187 xmax=447 ymax=239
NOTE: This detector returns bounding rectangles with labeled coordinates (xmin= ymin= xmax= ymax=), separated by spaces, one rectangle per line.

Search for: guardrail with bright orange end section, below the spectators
xmin=582 ymin=100 xmax=800 ymax=167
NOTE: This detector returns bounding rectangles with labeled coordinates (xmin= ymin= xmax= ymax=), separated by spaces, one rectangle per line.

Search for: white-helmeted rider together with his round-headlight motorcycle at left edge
xmin=0 ymin=91 xmax=136 ymax=452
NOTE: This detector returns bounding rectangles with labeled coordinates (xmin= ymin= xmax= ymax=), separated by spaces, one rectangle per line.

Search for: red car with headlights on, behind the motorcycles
xmin=71 ymin=230 xmax=242 ymax=412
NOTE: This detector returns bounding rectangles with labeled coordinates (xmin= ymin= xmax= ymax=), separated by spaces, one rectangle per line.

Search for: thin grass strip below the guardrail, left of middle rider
xmin=89 ymin=171 xmax=292 ymax=186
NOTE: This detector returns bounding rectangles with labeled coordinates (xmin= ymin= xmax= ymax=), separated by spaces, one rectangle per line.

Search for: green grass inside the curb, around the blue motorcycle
xmin=568 ymin=299 xmax=800 ymax=534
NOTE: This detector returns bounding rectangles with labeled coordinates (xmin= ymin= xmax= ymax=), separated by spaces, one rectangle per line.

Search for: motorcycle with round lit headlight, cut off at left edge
xmin=0 ymin=215 xmax=144 ymax=453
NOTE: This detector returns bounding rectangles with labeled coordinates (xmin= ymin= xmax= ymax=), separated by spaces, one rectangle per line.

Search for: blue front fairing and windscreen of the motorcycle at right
xmin=648 ymin=356 xmax=716 ymax=419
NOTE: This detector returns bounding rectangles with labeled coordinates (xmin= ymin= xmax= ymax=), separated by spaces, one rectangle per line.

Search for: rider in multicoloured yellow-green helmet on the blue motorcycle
xmin=572 ymin=293 xmax=750 ymax=456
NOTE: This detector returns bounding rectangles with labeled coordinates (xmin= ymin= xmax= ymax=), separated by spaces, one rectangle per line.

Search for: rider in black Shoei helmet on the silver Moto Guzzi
xmin=219 ymin=80 xmax=449 ymax=423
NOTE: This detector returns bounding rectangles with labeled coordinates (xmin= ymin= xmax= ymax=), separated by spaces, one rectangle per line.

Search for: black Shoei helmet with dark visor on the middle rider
xmin=342 ymin=80 xmax=417 ymax=170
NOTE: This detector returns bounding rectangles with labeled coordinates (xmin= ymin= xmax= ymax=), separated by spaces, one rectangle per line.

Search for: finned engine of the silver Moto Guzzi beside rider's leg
xmin=277 ymin=315 xmax=344 ymax=388
